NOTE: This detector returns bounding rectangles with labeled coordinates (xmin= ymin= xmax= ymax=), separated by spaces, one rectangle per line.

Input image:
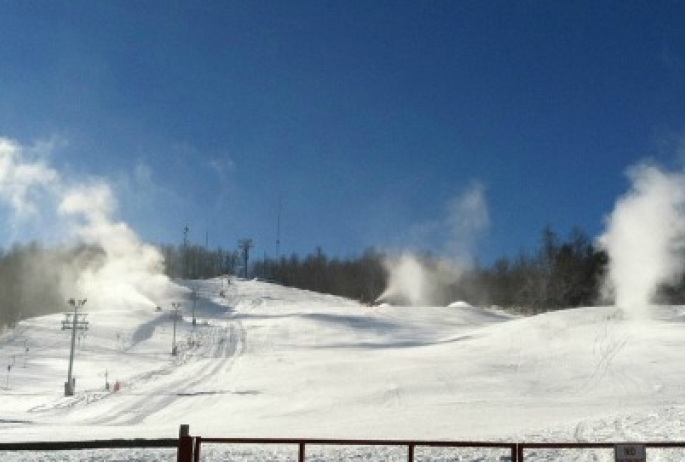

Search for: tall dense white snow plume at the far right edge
xmin=599 ymin=165 xmax=685 ymax=318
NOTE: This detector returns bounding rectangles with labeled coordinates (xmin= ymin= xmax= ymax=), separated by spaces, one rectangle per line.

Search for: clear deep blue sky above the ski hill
xmin=0 ymin=0 xmax=685 ymax=261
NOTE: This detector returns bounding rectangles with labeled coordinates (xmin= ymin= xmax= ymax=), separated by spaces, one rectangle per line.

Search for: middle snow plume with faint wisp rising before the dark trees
xmin=378 ymin=182 xmax=490 ymax=306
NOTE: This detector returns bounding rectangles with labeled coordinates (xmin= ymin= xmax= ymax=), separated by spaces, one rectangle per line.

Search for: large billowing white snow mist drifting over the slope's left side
xmin=0 ymin=138 xmax=180 ymax=308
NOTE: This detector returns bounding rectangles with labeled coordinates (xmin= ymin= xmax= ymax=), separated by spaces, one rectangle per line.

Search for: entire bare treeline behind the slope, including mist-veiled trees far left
xmin=6 ymin=228 xmax=685 ymax=327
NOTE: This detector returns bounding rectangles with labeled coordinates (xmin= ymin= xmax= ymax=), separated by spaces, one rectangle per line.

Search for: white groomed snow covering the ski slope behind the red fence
xmin=0 ymin=279 xmax=685 ymax=461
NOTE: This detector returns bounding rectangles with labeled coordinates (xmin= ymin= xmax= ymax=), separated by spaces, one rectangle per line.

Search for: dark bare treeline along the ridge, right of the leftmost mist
xmin=161 ymin=228 xmax=685 ymax=313
